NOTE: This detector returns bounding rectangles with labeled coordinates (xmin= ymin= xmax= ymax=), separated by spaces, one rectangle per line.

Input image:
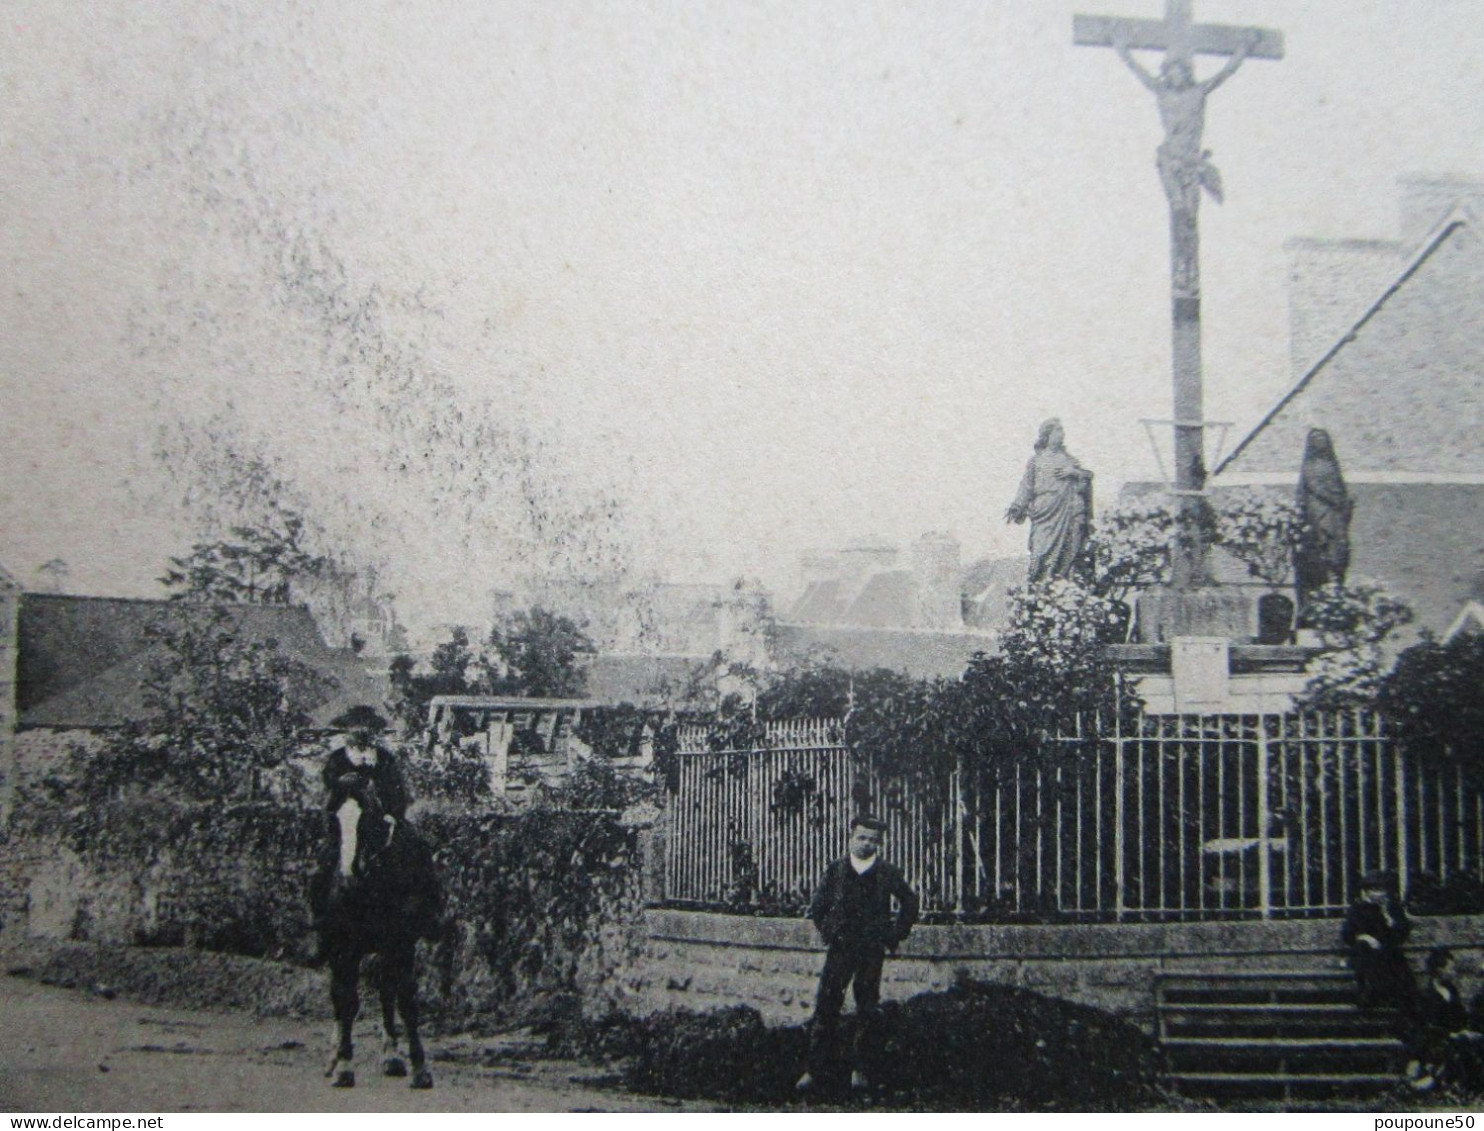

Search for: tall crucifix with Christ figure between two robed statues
xmin=1071 ymin=0 xmax=1284 ymax=591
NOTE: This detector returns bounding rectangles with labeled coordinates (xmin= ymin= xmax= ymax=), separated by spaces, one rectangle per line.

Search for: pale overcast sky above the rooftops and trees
xmin=0 ymin=0 xmax=1484 ymax=622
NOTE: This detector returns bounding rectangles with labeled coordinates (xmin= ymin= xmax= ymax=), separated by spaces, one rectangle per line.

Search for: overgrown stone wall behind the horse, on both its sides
xmin=0 ymin=800 xmax=644 ymax=1024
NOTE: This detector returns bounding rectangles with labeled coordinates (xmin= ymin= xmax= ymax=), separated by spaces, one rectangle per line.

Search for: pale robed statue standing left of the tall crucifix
xmin=1005 ymin=419 xmax=1092 ymax=583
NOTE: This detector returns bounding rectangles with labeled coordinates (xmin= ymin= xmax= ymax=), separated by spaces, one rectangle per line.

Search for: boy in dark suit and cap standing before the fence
xmin=797 ymin=816 xmax=917 ymax=1092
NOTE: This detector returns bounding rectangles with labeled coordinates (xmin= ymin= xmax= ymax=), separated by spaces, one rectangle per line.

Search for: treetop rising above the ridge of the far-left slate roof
xmin=160 ymin=509 xmax=334 ymax=604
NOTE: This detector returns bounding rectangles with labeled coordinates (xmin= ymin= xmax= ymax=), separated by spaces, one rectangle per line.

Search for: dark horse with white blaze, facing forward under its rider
xmin=319 ymin=773 xmax=442 ymax=1088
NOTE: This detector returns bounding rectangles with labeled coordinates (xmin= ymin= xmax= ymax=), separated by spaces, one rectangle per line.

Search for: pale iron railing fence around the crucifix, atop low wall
xmin=665 ymin=711 xmax=1484 ymax=922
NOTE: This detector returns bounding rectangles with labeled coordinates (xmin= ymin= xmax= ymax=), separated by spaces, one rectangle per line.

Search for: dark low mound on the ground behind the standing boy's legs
xmin=562 ymin=981 xmax=1158 ymax=1112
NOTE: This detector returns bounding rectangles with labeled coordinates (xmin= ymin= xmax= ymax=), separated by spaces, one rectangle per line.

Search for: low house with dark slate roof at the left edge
xmin=0 ymin=574 xmax=390 ymax=812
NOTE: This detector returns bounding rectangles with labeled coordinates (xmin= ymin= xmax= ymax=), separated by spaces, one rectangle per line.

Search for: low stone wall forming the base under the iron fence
xmin=623 ymin=908 xmax=1484 ymax=1026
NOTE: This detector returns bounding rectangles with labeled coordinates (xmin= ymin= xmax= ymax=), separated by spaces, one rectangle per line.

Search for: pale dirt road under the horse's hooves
xmin=0 ymin=977 xmax=700 ymax=1115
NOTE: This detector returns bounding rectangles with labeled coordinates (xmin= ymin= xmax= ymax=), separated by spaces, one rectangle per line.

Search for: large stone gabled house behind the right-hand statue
xmin=1209 ymin=178 xmax=1484 ymax=634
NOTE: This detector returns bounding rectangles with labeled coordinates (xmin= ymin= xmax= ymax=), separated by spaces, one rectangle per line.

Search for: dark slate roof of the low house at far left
xmin=16 ymin=592 xmax=390 ymax=729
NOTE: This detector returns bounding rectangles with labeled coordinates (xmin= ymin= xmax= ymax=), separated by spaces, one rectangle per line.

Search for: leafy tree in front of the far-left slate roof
xmin=64 ymin=609 xmax=332 ymax=801
